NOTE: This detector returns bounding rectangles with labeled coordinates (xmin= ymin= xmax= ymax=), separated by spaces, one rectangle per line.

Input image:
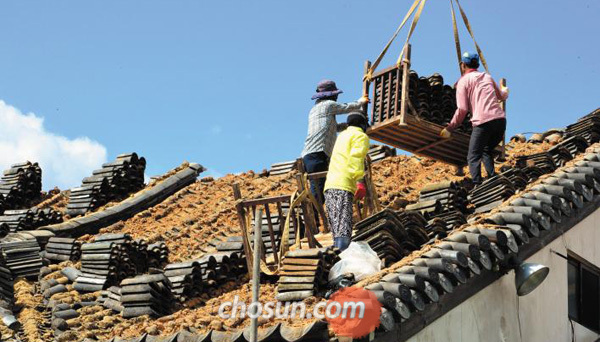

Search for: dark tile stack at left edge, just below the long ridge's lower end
xmin=0 ymin=238 xmax=42 ymax=279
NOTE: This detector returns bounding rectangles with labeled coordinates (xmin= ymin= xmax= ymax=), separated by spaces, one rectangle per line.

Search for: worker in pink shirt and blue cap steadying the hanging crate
xmin=440 ymin=52 xmax=508 ymax=185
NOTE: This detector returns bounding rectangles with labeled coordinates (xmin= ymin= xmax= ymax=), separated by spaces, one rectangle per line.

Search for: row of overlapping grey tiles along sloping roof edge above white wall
xmin=369 ymin=148 xmax=600 ymax=340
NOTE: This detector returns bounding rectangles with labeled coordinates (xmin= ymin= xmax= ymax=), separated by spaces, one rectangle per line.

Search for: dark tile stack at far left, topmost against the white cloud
xmin=0 ymin=161 xmax=42 ymax=210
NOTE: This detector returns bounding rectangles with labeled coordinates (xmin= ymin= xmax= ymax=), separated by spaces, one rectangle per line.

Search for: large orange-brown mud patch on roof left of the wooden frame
xmin=82 ymin=172 xmax=296 ymax=262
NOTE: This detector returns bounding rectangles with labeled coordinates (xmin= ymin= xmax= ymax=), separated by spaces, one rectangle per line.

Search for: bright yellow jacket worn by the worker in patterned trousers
xmin=325 ymin=126 xmax=369 ymax=194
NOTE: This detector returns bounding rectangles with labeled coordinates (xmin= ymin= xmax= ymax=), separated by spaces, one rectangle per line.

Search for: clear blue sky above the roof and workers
xmin=0 ymin=0 xmax=600 ymax=188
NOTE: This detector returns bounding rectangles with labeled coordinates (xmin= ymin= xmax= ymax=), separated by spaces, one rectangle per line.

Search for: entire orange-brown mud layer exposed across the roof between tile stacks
xmin=0 ymin=143 xmax=551 ymax=342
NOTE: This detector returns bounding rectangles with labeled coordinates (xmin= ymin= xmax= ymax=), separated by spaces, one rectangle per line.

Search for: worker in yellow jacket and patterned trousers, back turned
xmin=325 ymin=113 xmax=369 ymax=250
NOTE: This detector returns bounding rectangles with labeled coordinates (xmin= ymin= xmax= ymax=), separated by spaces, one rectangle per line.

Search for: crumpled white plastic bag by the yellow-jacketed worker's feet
xmin=329 ymin=241 xmax=381 ymax=281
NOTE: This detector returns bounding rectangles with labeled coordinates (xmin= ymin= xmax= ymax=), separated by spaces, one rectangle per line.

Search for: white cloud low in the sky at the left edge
xmin=0 ymin=100 xmax=106 ymax=189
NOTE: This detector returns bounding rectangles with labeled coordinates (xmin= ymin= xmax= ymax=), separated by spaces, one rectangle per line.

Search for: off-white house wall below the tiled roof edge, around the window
xmin=409 ymin=209 xmax=600 ymax=342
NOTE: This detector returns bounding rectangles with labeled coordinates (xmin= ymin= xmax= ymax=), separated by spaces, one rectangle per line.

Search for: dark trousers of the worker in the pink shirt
xmin=467 ymin=119 xmax=506 ymax=184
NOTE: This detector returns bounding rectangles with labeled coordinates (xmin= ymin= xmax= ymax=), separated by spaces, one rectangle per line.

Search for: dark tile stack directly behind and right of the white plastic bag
xmin=352 ymin=209 xmax=418 ymax=264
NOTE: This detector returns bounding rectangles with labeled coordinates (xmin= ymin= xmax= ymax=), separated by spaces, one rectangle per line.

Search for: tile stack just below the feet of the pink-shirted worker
xmin=468 ymin=175 xmax=516 ymax=213
